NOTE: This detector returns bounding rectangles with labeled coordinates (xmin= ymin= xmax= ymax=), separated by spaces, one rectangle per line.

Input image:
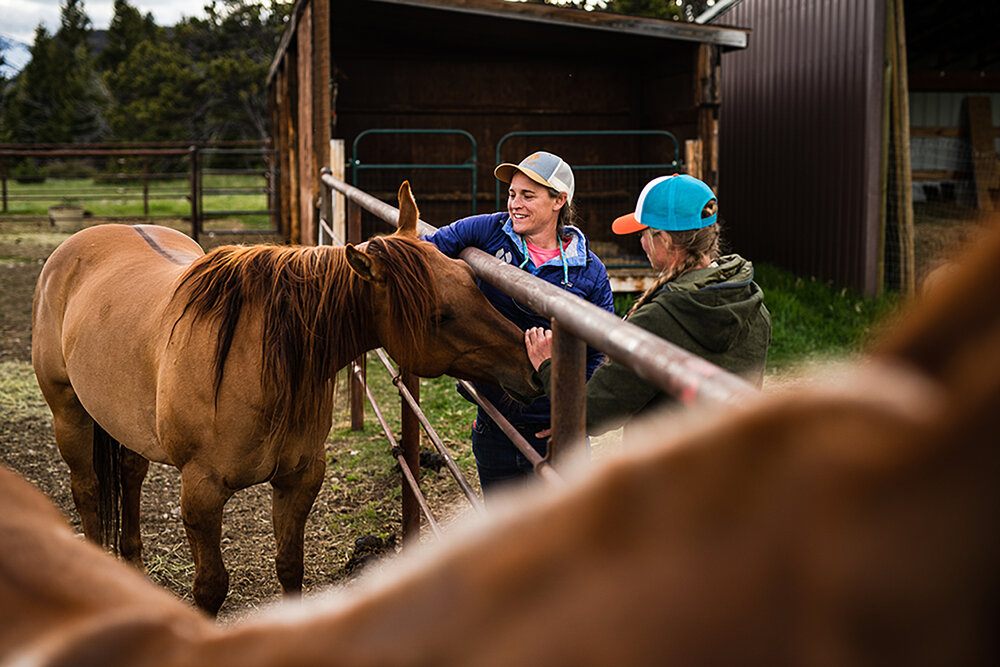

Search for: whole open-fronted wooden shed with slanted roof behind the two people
xmin=267 ymin=0 xmax=749 ymax=289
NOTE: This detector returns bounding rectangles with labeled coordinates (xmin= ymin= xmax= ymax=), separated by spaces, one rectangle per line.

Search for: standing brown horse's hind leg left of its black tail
xmin=49 ymin=392 xmax=101 ymax=544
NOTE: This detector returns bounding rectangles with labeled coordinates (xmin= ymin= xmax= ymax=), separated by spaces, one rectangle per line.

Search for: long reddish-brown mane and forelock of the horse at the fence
xmin=175 ymin=236 xmax=437 ymax=438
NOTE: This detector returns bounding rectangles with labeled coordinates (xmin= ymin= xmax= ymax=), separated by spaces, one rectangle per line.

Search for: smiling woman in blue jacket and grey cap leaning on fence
xmin=426 ymin=151 xmax=614 ymax=494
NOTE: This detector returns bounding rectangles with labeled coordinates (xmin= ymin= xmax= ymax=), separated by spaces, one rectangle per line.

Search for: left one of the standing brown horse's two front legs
xmin=181 ymin=464 xmax=232 ymax=616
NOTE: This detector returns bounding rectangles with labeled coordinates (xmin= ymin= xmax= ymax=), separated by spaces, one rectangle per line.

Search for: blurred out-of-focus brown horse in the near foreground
xmin=7 ymin=219 xmax=1000 ymax=667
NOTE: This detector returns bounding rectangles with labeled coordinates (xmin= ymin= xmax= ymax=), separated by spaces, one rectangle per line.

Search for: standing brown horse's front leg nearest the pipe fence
xmin=271 ymin=450 xmax=326 ymax=596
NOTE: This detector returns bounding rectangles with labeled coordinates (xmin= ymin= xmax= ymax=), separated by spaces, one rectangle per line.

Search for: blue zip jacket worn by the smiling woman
xmin=425 ymin=212 xmax=614 ymax=427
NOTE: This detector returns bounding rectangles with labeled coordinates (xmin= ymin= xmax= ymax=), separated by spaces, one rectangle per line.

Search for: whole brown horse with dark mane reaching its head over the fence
xmin=32 ymin=183 xmax=536 ymax=613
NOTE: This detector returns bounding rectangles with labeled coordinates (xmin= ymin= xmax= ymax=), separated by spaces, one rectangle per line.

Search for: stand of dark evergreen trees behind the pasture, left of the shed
xmin=0 ymin=0 xmax=293 ymax=143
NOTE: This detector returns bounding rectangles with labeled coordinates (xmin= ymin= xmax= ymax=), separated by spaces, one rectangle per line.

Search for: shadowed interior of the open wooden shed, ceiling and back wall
xmin=322 ymin=2 xmax=719 ymax=258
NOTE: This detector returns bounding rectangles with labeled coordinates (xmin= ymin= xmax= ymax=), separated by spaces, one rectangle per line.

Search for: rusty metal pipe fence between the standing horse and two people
xmin=319 ymin=168 xmax=758 ymax=538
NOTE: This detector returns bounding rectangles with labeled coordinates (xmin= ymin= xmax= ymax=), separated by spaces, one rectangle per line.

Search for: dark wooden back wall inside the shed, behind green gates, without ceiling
xmin=335 ymin=54 xmax=697 ymax=247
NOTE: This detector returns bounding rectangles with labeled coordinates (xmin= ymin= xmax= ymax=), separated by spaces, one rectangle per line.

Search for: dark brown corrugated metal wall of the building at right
xmin=719 ymin=0 xmax=885 ymax=294
